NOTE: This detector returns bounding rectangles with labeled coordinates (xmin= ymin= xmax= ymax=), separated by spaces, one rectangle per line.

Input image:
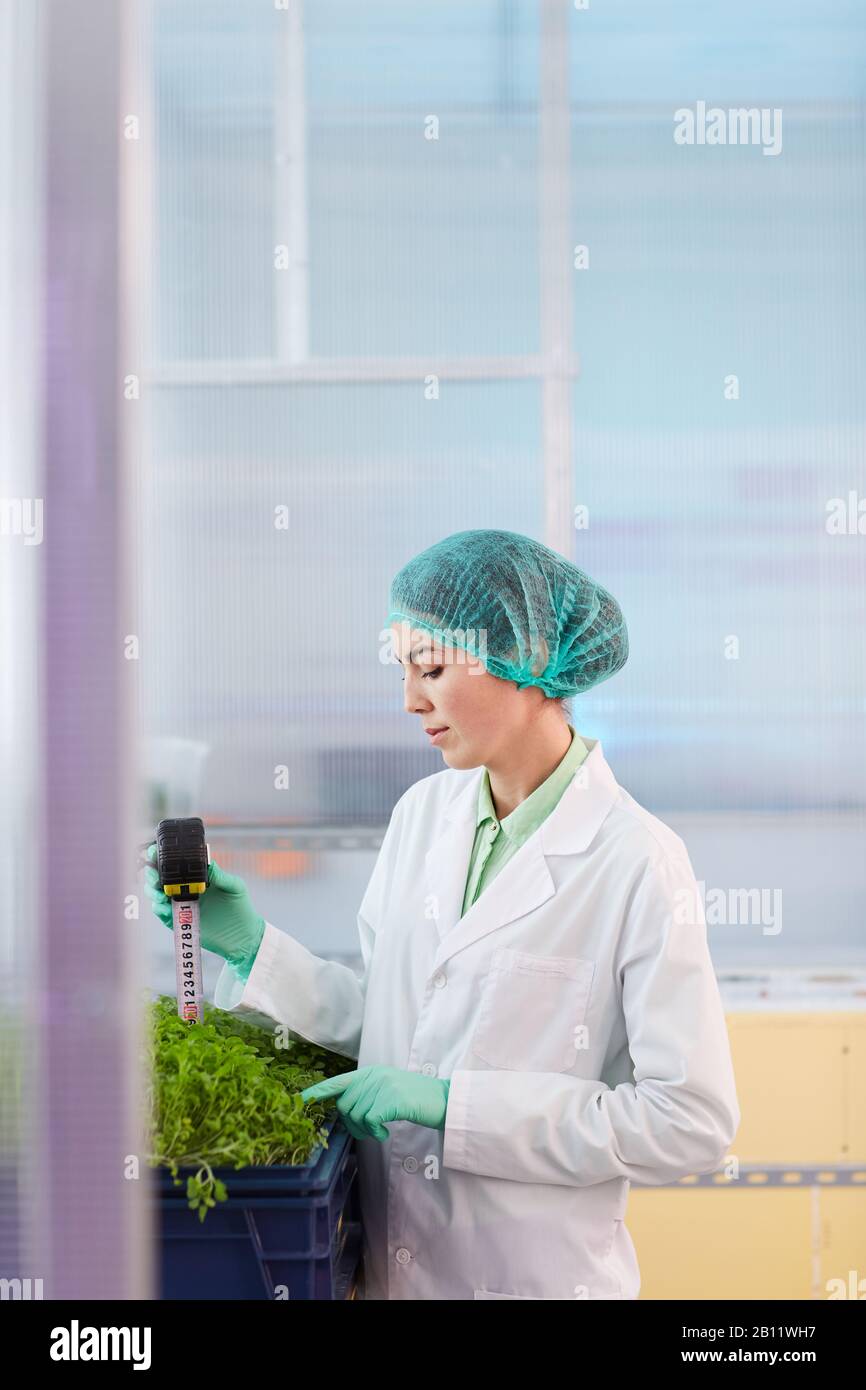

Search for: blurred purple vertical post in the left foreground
xmin=35 ymin=0 xmax=150 ymax=1300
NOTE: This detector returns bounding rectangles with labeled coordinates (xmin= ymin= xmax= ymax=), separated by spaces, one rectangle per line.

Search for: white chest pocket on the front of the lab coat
xmin=471 ymin=947 xmax=595 ymax=1072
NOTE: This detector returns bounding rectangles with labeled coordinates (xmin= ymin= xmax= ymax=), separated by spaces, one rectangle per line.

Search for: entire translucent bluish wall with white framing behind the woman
xmin=136 ymin=0 xmax=866 ymax=984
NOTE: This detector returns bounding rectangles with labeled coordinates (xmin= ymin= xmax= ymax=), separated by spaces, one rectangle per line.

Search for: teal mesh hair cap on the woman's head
xmin=385 ymin=531 xmax=628 ymax=699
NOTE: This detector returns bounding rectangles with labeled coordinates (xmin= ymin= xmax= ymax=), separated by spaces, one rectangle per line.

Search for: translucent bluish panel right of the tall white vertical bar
xmin=561 ymin=0 xmax=866 ymax=810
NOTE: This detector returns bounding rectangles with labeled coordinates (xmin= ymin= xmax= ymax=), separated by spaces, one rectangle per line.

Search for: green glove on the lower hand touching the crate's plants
xmin=300 ymin=1066 xmax=450 ymax=1141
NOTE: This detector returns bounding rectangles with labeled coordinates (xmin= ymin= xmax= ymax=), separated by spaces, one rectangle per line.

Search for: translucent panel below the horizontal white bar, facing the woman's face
xmin=138 ymin=382 xmax=541 ymax=824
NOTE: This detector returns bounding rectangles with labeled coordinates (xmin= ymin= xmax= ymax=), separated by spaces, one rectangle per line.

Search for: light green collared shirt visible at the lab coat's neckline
xmin=460 ymin=724 xmax=589 ymax=916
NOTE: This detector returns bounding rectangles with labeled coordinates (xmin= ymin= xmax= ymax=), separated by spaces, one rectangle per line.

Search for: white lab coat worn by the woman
xmin=215 ymin=738 xmax=740 ymax=1300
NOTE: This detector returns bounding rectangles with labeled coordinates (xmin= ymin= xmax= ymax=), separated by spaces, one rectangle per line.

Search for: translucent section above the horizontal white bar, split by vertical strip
xmin=153 ymin=0 xmax=538 ymax=361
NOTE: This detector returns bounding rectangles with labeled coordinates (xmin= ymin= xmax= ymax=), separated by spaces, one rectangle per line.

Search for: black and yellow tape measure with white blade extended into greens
xmin=156 ymin=816 xmax=210 ymax=1023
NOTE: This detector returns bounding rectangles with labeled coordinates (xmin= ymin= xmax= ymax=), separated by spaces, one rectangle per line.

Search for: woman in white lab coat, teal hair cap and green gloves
xmin=142 ymin=531 xmax=740 ymax=1300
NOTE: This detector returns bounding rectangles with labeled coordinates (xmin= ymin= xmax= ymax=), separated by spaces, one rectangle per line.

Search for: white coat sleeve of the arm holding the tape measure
xmin=214 ymin=796 xmax=403 ymax=1058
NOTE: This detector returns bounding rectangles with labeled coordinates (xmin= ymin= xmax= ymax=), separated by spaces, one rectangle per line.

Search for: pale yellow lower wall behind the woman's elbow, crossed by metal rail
xmin=626 ymin=1011 xmax=866 ymax=1300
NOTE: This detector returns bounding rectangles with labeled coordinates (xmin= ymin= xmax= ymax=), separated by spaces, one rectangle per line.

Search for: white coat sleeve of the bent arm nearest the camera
xmin=442 ymin=855 xmax=740 ymax=1187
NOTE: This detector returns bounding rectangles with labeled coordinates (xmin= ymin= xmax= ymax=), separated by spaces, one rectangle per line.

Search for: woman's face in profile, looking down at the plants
xmin=391 ymin=623 xmax=544 ymax=769
